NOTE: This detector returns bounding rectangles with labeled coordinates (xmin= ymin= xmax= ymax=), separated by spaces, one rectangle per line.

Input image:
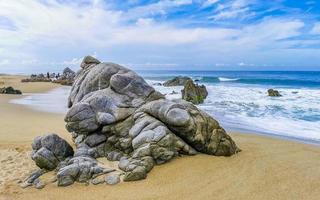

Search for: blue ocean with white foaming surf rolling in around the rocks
xmin=14 ymin=71 xmax=320 ymax=143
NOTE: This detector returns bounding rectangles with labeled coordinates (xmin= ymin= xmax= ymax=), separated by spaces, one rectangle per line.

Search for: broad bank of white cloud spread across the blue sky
xmin=0 ymin=0 xmax=319 ymax=71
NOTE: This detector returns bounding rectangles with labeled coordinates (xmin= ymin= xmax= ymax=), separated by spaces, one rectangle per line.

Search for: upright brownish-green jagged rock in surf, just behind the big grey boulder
xmin=181 ymin=80 xmax=208 ymax=105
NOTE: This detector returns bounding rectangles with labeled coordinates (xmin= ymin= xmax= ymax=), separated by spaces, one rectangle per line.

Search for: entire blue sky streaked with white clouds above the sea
xmin=0 ymin=0 xmax=320 ymax=73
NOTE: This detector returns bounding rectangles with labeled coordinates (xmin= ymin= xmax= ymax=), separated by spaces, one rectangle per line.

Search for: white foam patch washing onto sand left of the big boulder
xmin=10 ymin=86 xmax=71 ymax=114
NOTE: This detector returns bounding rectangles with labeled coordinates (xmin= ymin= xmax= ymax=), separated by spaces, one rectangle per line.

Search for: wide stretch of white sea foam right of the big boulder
xmin=149 ymin=81 xmax=320 ymax=141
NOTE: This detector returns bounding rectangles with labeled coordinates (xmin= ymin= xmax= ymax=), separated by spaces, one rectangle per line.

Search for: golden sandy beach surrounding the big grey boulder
xmin=0 ymin=77 xmax=320 ymax=200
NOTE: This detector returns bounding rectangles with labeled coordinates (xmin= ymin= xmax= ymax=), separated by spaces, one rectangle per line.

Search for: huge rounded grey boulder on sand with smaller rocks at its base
xmin=26 ymin=57 xmax=240 ymax=186
